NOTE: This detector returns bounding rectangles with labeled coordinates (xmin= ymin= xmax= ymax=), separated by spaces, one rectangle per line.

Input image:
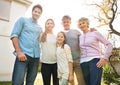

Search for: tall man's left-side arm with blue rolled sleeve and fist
xmin=10 ymin=17 xmax=26 ymax=61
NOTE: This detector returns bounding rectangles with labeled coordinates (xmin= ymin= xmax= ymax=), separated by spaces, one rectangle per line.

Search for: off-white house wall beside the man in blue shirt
xmin=0 ymin=0 xmax=31 ymax=81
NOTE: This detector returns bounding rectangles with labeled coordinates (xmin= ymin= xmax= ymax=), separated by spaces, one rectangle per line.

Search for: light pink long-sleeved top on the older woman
xmin=79 ymin=31 xmax=112 ymax=59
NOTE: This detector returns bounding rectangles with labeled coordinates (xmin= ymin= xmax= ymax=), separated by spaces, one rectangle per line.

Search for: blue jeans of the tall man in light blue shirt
xmin=12 ymin=55 xmax=39 ymax=85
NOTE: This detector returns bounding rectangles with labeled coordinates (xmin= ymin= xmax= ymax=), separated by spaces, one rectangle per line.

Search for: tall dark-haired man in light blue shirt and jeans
xmin=11 ymin=5 xmax=42 ymax=85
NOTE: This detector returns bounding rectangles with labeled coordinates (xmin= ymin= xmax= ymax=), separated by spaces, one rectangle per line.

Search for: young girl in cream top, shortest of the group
xmin=57 ymin=32 xmax=73 ymax=85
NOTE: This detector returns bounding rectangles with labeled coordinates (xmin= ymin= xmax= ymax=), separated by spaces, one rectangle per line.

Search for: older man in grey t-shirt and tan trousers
xmin=62 ymin=15 xmax=85 ymax=85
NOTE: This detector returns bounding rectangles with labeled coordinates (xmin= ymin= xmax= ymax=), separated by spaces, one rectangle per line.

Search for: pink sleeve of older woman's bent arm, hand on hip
xmin=96 ymin=31 xmax=113 ymax=59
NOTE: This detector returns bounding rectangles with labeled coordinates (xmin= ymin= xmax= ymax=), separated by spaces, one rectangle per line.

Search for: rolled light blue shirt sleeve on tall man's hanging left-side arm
xmin=10 ymin=17 xmax=24 ymax=39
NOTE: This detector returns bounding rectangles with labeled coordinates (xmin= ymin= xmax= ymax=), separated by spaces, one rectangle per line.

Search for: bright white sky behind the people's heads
xmin=26 ymin=0 xmax=120 ymax=47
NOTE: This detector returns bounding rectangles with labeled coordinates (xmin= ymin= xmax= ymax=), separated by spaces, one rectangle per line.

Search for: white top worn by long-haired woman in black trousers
xmin=41 ymin=34 xmax=57 ymax=64
